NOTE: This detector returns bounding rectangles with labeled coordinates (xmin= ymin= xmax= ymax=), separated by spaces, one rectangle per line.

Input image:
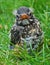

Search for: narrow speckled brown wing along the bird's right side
xmin=34 ymin=18 xmax=44 ymax=43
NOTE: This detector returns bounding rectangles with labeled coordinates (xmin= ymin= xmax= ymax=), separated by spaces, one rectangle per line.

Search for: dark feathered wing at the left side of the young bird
xmin=10 ymin=24 xmax=20 ymax=44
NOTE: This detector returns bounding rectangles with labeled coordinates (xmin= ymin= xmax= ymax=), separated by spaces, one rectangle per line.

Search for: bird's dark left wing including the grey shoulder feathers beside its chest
xmin=10 ymin=23 xmax=24 ymax=44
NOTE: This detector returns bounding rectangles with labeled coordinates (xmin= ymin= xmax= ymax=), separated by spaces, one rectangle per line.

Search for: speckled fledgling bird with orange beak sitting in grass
xmin=10 ymin=6 xmax=43 ymax=51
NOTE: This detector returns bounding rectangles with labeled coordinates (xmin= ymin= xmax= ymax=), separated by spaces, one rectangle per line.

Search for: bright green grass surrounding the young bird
xmin=0 ymin=0 xmax=50 ymax=65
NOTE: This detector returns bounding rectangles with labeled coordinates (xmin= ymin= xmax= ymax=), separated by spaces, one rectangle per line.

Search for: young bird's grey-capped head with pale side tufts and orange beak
xmin=13 ymin=6 xmax=33 ymax=24
